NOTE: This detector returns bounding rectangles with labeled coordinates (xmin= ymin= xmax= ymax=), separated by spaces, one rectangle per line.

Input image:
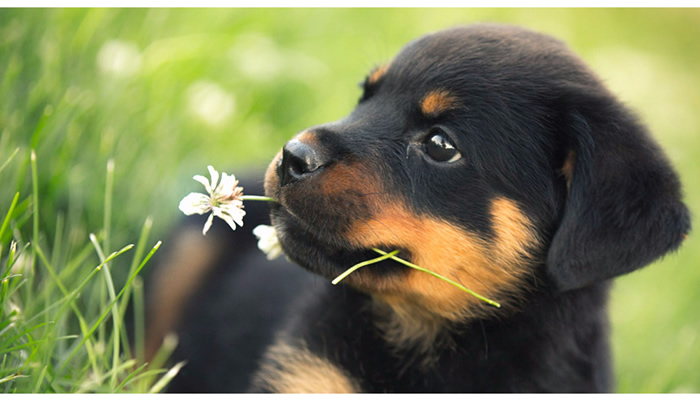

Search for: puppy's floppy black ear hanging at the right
xmin=546 ymin=96 xmax=690 ymax=290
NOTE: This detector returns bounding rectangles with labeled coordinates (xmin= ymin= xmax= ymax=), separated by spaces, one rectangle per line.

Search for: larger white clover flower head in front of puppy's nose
xmin=179 ymin=165 xmax=245 ymax=235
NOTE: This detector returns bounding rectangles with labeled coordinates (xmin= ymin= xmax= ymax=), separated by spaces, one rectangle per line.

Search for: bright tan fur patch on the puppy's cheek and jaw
xmin=347 ymin=198 xmax=539 ymax=320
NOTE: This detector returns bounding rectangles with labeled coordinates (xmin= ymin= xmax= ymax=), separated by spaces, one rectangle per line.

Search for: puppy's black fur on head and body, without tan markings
xmin=152 ymin=25 xmax=690 ymax=392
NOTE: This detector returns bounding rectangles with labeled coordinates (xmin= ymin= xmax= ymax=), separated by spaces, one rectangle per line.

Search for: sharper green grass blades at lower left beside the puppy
xmin=0 ymin=150 xmax=173 ymax=393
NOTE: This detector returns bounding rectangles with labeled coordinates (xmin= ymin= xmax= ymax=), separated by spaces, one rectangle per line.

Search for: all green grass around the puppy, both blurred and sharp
xmin=0 ymin=9 xmax=700 ymax=393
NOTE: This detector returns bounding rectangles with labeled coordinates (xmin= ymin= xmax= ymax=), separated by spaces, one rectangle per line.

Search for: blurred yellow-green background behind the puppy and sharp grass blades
xmin=0 ymin=9 xmax=700 ymax=392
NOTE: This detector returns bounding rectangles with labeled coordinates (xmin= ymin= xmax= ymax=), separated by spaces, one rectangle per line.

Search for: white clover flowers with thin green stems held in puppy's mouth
xmin=179 ymin=166 xmax=501 ymax=307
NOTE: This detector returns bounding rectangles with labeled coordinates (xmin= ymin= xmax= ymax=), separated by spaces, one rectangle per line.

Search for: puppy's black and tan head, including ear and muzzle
xmin=265 ymin=25 xmax=689 ymax=319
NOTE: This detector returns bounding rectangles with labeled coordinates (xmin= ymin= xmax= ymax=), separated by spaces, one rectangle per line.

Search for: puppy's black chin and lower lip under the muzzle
xmin=272 ymin=206 xmax=405 ymax=289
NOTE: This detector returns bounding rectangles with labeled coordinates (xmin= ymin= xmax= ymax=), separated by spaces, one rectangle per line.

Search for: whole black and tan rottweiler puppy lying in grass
xmin=150 ymin=24 xmax=690 ymax=392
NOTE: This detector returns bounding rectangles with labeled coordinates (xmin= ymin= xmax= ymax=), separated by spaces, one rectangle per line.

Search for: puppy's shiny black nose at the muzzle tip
xmin=277 ymin=139 xmax=328 ymax=186
